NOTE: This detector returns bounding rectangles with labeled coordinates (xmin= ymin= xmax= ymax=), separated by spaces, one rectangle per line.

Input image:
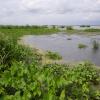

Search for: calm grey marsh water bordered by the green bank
xmin=22 ymin=33 xmax=100 ymax=66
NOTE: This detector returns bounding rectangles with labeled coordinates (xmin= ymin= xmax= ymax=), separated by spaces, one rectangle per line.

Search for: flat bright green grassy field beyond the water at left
xmin=0 ymin=26 xmax=59 ymax=41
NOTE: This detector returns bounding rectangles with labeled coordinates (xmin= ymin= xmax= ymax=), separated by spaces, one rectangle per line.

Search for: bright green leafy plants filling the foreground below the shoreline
xmin=0 ymin=62 xmax=100 ymax=100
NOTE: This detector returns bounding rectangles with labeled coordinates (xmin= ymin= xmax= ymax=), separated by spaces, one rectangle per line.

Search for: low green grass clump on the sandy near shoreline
xmin=46 ymin=51 xmax=62 ymax=60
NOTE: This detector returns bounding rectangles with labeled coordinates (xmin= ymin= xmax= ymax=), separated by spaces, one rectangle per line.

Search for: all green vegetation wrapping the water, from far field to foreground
xmin=0 ymin=28 xmax=100 ymax=100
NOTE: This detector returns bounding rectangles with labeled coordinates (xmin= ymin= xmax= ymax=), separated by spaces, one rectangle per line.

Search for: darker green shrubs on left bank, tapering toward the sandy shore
xmin=0 ymin=34 xmax=41 ymax=70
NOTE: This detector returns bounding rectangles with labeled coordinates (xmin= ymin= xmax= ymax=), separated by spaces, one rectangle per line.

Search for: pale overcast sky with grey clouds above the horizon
xmin=0 ymin=0 xmax=100 ymax=25
